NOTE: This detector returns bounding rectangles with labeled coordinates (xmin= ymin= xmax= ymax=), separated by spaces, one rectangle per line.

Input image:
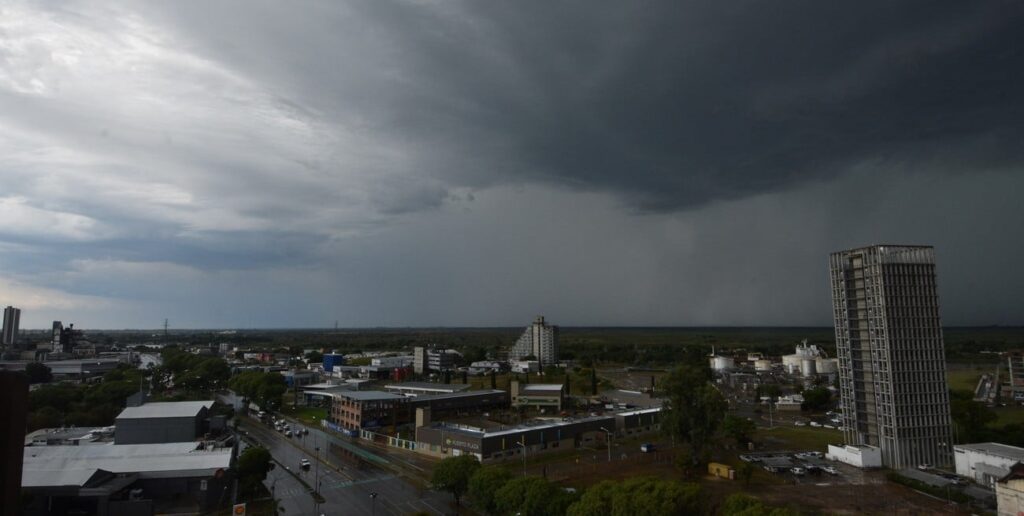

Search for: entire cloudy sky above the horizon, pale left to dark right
xmin=0 ymin=0 xmax=1024 ymax=328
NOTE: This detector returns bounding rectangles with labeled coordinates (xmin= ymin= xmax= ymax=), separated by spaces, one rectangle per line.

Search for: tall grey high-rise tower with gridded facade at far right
xmin=829 ymin=246 xmax=953 ymax=468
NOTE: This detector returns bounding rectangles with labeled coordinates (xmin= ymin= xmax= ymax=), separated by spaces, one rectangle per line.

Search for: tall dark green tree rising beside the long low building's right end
xmin=662 ymin=366 xmax=728 ymax=466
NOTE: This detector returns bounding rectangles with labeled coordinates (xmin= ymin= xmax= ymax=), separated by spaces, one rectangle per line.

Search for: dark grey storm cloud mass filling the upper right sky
xmin=148 ymin=1 xmax=1024 ymax=212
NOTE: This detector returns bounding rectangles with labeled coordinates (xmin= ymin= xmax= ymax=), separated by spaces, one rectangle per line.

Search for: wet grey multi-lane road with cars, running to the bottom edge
xmin=241 ymin=419 xmax=453 ymax=515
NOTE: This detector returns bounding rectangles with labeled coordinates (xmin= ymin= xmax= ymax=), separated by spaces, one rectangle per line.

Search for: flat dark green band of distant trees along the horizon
xmin=101 ymin=327 xmax=1024 ymax=366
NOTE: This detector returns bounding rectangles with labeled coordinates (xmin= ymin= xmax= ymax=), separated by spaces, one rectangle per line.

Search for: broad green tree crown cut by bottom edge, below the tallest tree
xmin=566 ymin=477 xmax=702 ymax=516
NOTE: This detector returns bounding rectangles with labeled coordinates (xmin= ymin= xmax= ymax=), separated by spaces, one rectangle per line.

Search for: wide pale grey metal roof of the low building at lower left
xmin=22 ymin=442 xmax=231 ymax=487
